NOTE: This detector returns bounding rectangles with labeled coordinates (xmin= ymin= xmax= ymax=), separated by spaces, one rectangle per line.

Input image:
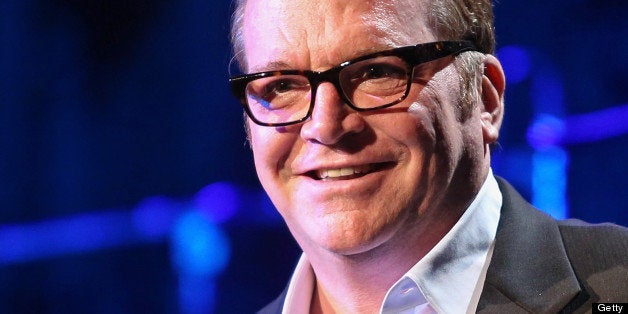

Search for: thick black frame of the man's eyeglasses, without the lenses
xmin=229 ymin=40 xmax=480 ymax=127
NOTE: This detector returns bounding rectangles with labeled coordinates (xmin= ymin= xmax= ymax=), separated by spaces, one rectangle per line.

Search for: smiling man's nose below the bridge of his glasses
xmin=301 ymin=82 xmax=365 ymax=145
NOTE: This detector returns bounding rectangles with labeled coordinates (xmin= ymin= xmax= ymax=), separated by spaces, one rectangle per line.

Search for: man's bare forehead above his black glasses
xmin=244 ymin=0 xmax=434 ymax=72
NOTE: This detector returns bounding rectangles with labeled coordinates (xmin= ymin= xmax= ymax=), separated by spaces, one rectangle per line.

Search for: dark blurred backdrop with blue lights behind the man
xmin=0 ymin=0 xmax=628 ymax=313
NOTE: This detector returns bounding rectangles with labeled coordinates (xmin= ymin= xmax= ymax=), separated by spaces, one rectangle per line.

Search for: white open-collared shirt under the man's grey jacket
xmin=282 ymin=171 xmax=502 ymax=314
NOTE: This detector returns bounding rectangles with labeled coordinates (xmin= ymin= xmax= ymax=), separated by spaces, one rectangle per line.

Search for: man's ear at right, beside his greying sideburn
xmin=480 ymin=55 xmax=506 ymax=144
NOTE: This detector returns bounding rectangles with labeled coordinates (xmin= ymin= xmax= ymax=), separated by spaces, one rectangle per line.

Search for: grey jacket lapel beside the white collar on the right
xmin=478 ymin=178 xmax=580 ymax=313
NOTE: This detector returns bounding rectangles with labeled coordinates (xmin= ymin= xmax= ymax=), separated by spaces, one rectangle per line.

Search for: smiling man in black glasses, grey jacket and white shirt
xmin=231 ymin=0 xmax=628 ymax=313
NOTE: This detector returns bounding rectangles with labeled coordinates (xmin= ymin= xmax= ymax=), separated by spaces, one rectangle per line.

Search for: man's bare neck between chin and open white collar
xmin=308 ymin=206 xmax=462 ymax=313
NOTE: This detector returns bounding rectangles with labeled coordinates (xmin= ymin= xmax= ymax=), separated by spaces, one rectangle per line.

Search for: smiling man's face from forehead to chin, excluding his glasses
xmin=243 ymin=0 xmax=494 ymax=254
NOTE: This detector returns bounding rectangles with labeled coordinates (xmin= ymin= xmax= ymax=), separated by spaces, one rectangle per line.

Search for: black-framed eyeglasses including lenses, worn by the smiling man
xmin=229 ymin=41 xmax=477 ymax=126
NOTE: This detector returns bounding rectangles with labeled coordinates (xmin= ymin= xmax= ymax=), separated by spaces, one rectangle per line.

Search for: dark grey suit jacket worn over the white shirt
xmin=259 ymin=178 xmax=628 ymax=314
